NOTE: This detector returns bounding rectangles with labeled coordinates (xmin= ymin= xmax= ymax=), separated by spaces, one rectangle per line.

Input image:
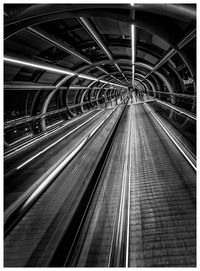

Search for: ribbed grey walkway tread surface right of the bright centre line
xmin=129 ymin=104 xmax=196 ymax=267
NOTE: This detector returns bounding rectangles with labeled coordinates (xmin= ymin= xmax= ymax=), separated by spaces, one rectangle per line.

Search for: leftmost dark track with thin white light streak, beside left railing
xmin=4 ymin=110 xmax=110 ymax=209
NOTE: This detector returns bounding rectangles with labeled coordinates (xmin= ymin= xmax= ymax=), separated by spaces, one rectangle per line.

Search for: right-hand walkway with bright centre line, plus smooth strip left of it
xmin=65 ymin=104 xmax=195 ymax=267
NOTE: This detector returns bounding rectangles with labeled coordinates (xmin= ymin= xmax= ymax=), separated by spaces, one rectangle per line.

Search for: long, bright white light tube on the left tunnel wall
xmin=4 ymin=57 xmax=75 ymax=75
